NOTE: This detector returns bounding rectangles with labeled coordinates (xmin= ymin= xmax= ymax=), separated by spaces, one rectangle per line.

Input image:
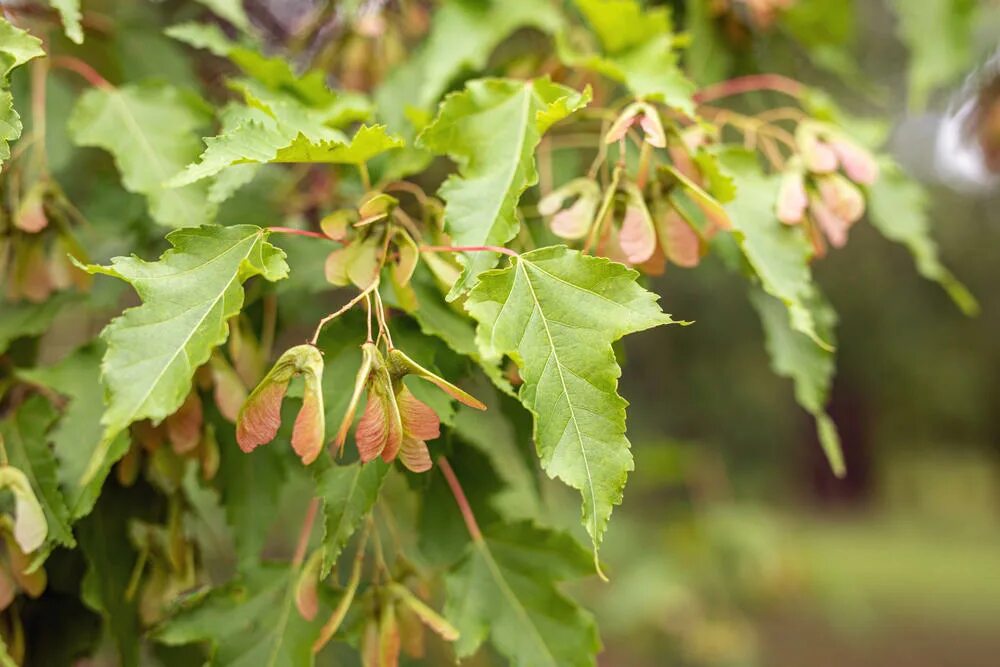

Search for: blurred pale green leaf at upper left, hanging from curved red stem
xmin=69 ymin=83 xmax=215 ymax=227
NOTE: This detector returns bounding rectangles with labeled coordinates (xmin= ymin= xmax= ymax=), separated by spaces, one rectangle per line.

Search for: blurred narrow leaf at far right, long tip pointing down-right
xmin=868 ymin=159 xmax=979 ymax=315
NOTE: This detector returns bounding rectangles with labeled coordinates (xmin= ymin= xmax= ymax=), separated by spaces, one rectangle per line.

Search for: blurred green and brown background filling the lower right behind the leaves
xmin=572 ymin=0 xmax=1000 ymax=667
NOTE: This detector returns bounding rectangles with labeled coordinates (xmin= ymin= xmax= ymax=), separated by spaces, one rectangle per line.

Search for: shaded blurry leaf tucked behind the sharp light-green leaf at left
xmin=18 ymin=345 xmax=129 ymax=520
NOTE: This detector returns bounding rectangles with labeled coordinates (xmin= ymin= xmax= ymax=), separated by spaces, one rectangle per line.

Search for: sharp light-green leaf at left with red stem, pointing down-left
xmin=73 ymin=225 xmax=288 ymax=506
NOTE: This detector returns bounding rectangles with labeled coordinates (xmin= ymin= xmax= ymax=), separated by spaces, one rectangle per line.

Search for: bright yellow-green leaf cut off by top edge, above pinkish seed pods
xmin=558 ymin=0 xmax=695 ymax=116
